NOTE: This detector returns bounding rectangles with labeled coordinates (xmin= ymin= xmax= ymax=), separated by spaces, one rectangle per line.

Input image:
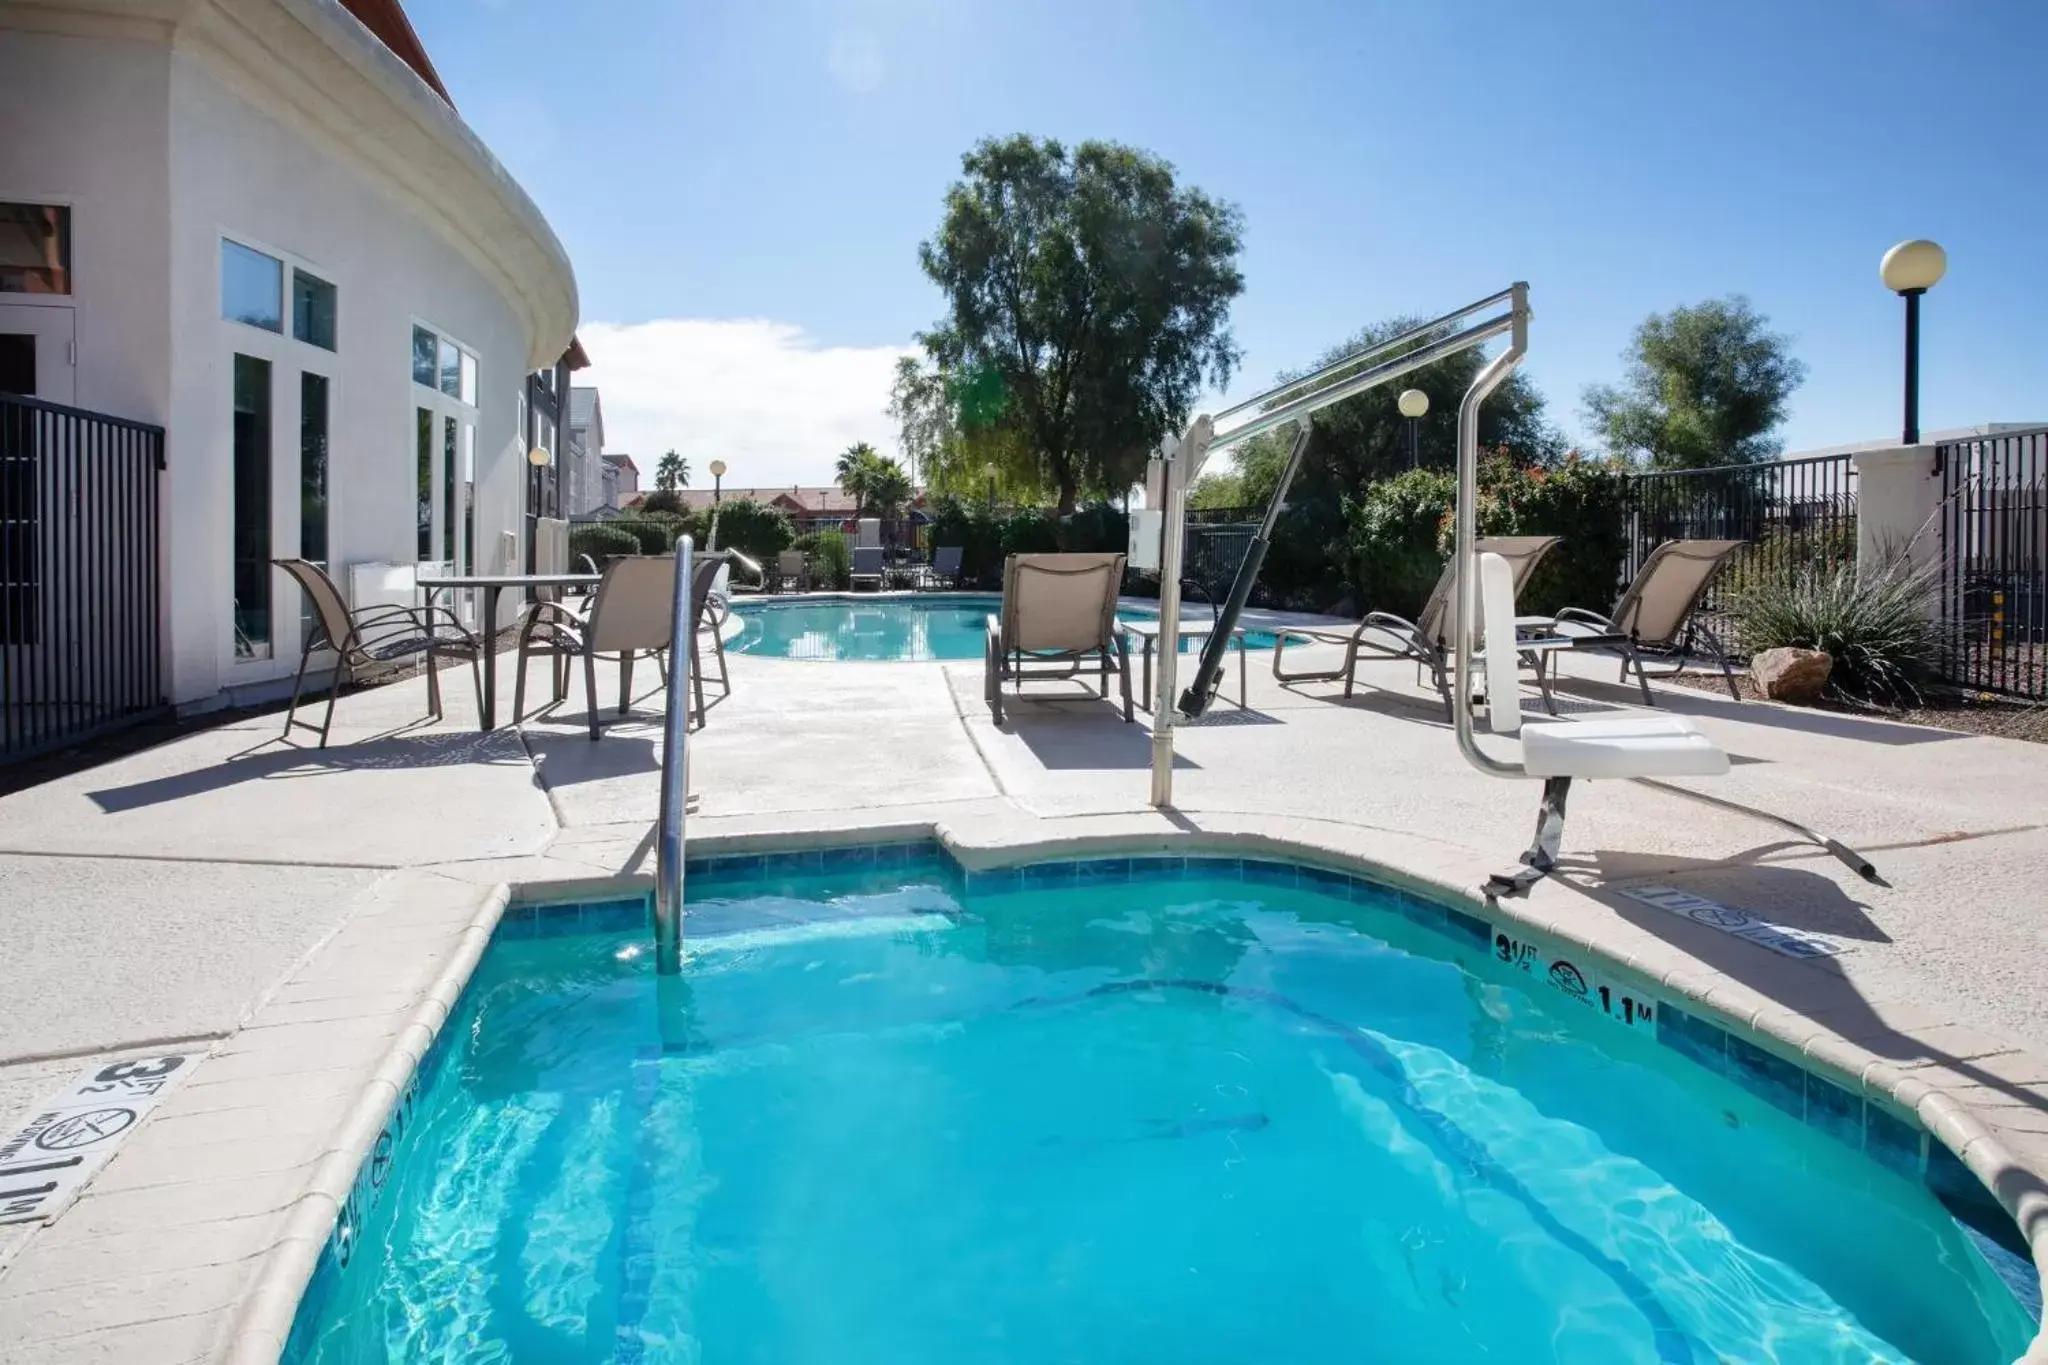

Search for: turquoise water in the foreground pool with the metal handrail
xmin=291 ymin=864 xmax=2032 ymax=1365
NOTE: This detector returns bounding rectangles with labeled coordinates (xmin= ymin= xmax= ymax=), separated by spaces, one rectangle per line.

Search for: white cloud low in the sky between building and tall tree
xmin=575 ymin=317 xmax=911 ymax=487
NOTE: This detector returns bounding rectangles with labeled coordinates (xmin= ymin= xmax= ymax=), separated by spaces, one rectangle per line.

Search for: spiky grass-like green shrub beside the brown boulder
xmin=1729 ymin=555 xmax=1939 ymax=700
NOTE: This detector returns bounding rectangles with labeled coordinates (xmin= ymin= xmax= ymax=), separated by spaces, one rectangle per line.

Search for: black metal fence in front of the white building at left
xmin=0 ymin=393 xmax=164 ymax=761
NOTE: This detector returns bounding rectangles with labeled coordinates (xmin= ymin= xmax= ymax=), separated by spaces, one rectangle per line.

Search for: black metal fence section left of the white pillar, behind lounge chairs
xmin=1616 ymin=454 xmax=1855 ymax=645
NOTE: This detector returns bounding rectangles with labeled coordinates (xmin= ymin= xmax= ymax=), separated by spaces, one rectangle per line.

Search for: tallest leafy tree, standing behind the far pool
xmin=918 ymin=135 xmax=1243 ymax=516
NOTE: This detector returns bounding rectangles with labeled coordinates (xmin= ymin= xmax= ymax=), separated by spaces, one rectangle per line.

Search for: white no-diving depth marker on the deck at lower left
xmin=0 ymin=1054 xmax=197 ymax=1224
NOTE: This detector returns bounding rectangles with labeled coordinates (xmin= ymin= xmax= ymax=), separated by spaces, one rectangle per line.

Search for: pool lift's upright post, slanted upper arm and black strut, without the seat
xmin=1151 ymin=284 xmax=1528 ymax=806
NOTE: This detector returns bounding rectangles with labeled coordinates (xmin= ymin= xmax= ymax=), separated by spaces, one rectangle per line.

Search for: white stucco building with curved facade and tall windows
xmin=0 ymin=0 xmax=578 ymax=706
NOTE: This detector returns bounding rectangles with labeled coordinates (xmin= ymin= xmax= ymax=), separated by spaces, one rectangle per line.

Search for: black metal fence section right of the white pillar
xmin=1935 ymin=430 xmax=2048 ymax=700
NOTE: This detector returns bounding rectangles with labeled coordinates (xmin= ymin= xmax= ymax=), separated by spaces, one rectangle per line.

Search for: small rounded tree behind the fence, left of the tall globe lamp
xmin=1585 ymin=295 xmax=1806 ymax=469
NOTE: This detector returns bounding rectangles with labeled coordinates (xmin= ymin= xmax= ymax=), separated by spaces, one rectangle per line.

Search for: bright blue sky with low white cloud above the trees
xmin=408 ymin=0 xmax=2048 ymax=485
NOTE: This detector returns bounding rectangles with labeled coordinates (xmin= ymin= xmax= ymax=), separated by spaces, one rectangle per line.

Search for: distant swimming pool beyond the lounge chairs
xmin=727 ymin=593 xmax=1274 ymax=663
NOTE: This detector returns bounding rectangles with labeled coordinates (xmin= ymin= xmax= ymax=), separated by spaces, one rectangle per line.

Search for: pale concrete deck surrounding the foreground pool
xmin=0 ymin=634 xmax=2048 ymax=1365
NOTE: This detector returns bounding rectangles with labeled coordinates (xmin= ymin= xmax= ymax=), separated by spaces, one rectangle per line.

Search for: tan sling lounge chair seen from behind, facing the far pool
xmin=981 ymin=553 xmax=1130 ymax=724
